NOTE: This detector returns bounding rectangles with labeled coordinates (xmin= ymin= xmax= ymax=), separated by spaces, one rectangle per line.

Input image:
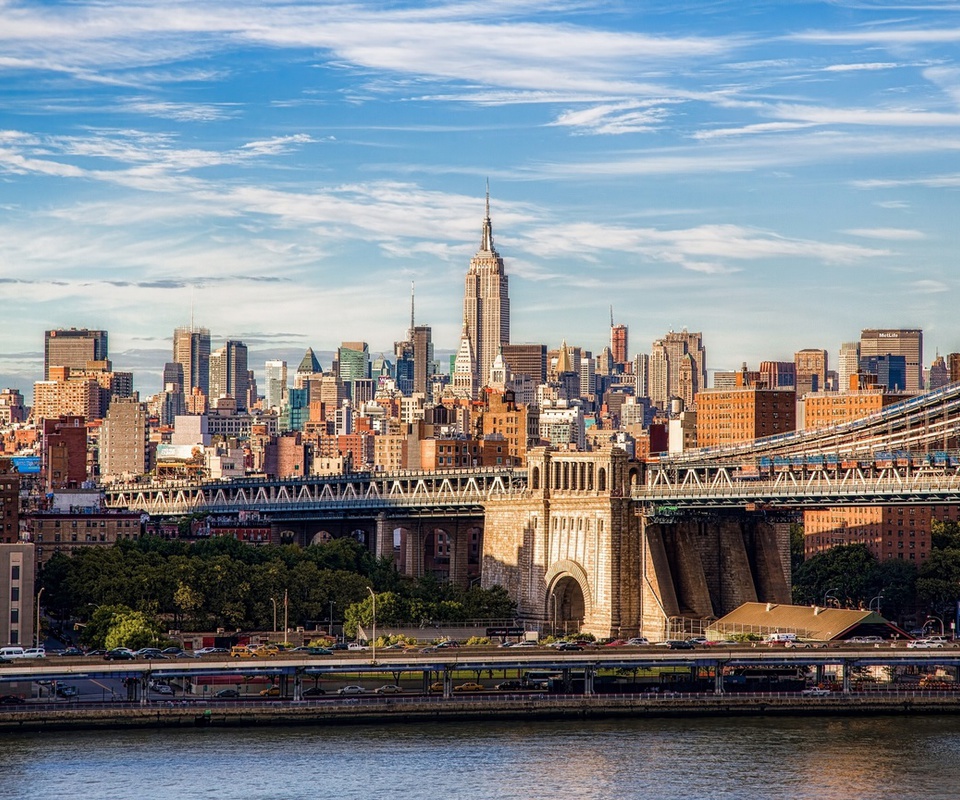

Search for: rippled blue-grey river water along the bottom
xmin=0 ymin=715 xmax=960 ymax=800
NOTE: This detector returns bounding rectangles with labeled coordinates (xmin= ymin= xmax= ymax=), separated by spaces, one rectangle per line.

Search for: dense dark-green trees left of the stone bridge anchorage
xmin=40 ymin=536 xmax=515 ymax=646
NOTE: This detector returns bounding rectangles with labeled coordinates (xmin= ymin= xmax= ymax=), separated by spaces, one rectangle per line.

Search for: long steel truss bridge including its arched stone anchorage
xmin=107 ymin=384 xmax=960 ymax=638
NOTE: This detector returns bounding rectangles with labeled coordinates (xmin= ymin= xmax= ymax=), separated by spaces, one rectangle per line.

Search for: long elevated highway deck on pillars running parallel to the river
xmin=0 ymin=645 xmax=960 ymax=698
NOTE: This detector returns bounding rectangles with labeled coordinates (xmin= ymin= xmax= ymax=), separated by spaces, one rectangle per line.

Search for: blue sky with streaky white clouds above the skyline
xmin=0 ymin=0 xmax=960 ymax=398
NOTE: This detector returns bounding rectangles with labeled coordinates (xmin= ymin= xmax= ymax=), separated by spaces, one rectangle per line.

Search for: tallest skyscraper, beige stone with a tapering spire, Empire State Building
xmin=463 ymin=189 xmax=510 ymax=387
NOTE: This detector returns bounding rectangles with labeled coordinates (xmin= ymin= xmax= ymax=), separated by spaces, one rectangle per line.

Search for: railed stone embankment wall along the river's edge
xmin=0 ymin=692 xmax=960 ymax=732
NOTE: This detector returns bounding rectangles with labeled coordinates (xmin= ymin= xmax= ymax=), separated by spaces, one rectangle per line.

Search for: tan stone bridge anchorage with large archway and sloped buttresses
xmin=481 ymin=448 xmax=790 ymax=639
